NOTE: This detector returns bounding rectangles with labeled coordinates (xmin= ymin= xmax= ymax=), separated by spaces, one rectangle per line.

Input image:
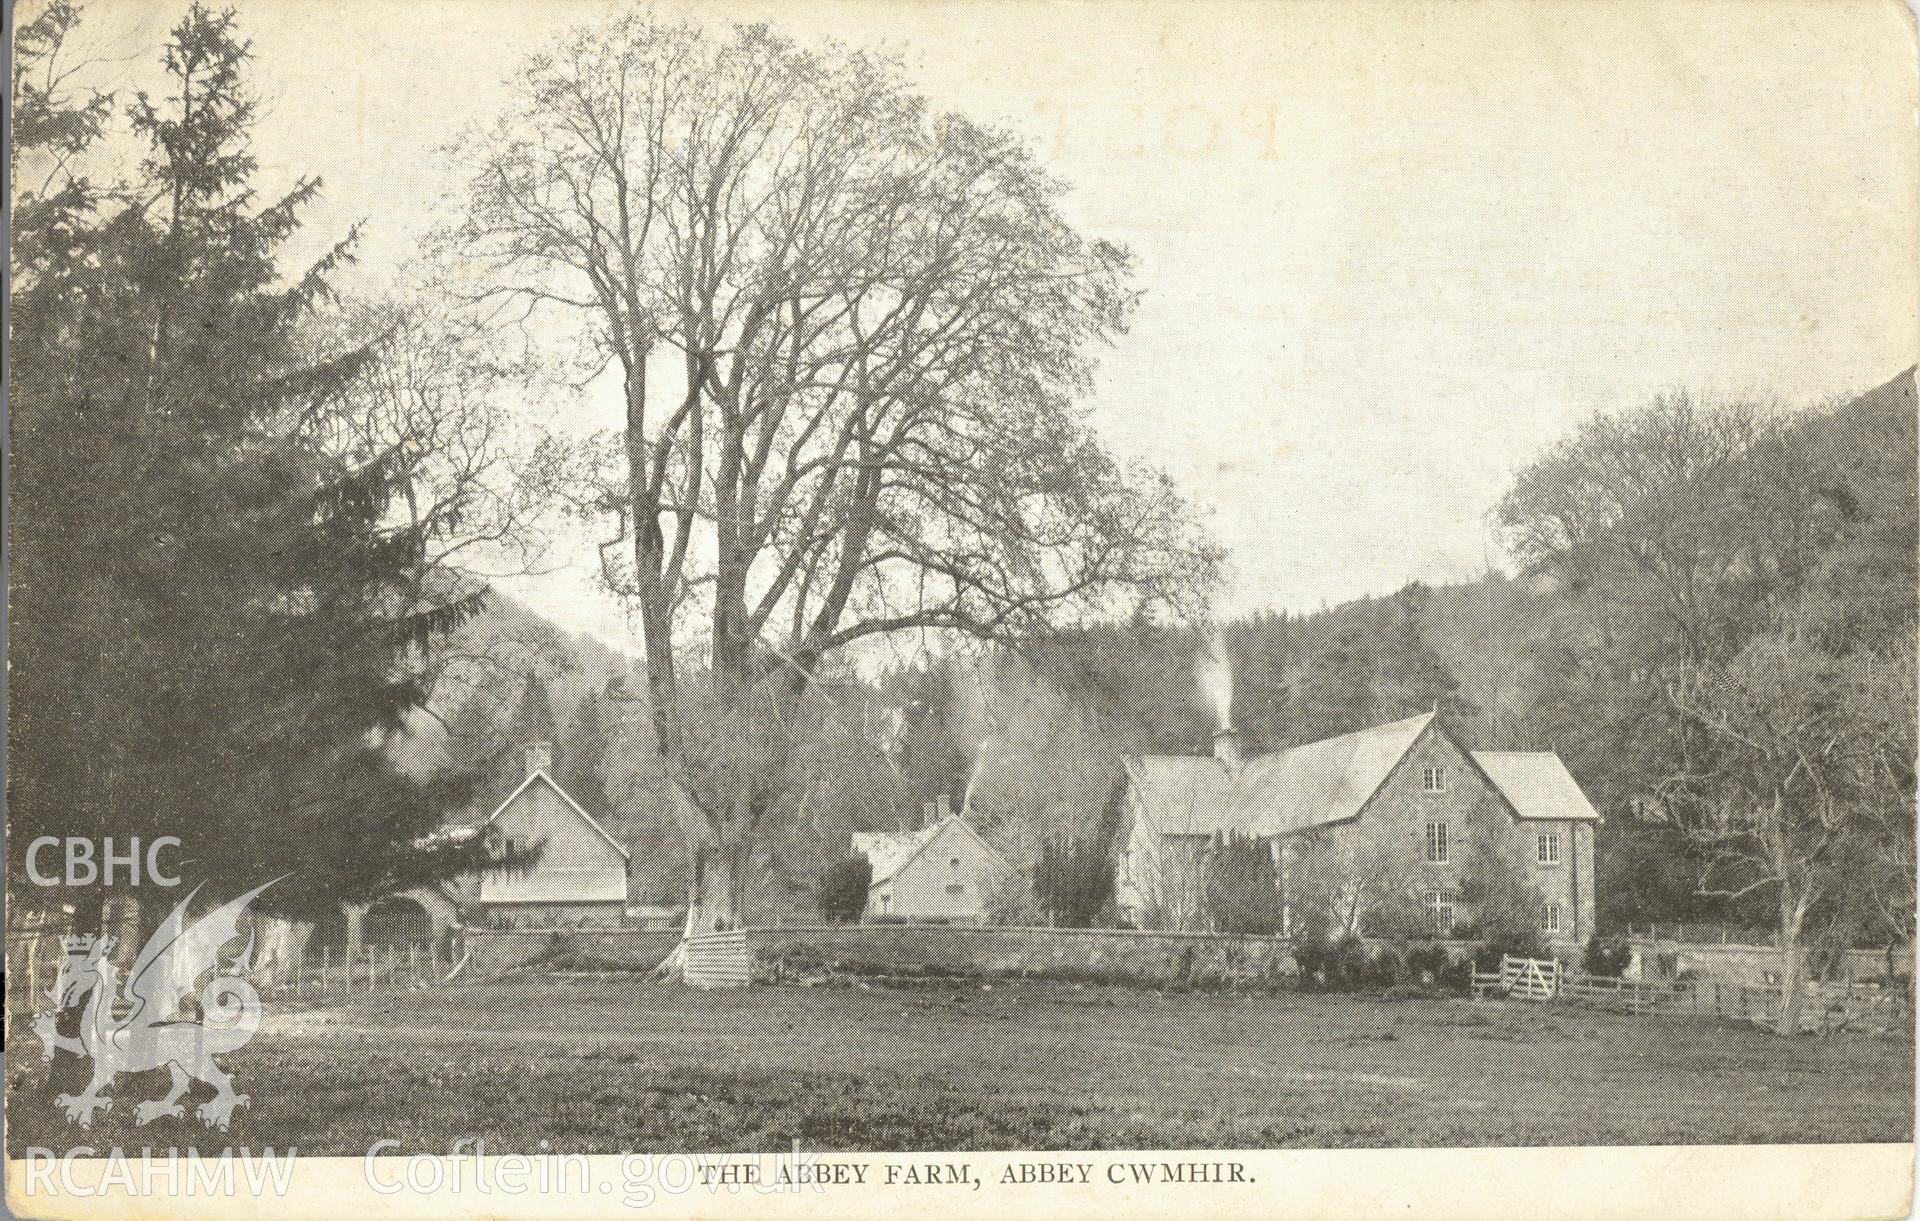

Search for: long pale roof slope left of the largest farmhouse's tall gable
xmin=1127 ymin=712 xmax=1434 ymax=835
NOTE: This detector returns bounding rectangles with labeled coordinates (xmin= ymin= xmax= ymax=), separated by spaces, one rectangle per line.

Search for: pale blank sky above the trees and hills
xmin=74 ymin=0 xmax=1916 ymax=647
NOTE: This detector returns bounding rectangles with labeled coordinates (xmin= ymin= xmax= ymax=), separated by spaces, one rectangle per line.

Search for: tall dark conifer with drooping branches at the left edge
xmin=10 ymin=4 xmax=482 ymax=923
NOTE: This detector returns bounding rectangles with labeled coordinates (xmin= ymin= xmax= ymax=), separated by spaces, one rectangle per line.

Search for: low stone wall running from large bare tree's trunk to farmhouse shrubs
xmin=747 ymin=923 xmax=1296 ymax=983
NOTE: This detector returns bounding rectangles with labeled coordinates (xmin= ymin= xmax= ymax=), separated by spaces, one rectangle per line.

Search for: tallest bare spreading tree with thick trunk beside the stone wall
xmin=445 ymin=15 xmax=1215 ymax=927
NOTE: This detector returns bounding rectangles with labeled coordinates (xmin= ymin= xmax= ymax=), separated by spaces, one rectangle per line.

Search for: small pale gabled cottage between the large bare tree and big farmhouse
xmin=852 ymin=814 xmax=1012 ymax=923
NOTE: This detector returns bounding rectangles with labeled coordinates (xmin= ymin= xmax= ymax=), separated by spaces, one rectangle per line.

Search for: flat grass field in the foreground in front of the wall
xmin=8 ymin=979 xmax=1914 ymax=1156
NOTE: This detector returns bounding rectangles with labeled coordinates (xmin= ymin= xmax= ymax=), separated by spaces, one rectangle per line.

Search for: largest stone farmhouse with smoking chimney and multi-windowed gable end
xmin=1116 ymin=712 xmax=1599 ymax=946
